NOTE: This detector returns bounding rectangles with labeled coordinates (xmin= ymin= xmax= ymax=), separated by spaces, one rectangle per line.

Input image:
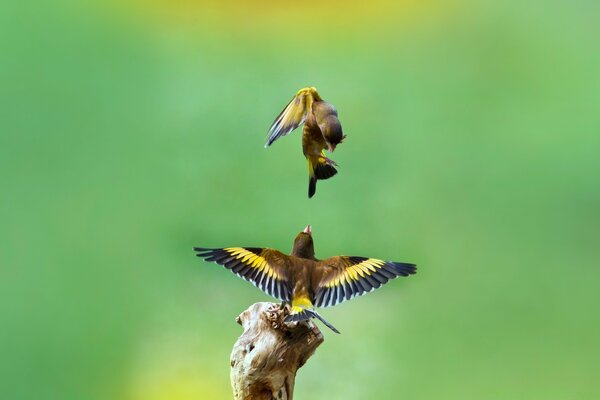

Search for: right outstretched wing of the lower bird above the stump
xmin=314 ymin=256 xmax=417 ymax=307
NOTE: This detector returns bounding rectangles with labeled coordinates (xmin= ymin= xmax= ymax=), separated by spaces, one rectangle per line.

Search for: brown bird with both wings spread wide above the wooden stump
xmin=194 ymin=225 xmax=416 ymax=333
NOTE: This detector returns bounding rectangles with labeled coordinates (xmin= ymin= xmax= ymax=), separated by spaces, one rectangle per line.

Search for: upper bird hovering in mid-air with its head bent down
xmin=265 ymin=86 xmax=346 ymax=198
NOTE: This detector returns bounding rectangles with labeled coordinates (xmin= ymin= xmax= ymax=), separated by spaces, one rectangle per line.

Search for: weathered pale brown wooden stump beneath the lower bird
xmin=231 ymin=302 xmax=323 ymax=400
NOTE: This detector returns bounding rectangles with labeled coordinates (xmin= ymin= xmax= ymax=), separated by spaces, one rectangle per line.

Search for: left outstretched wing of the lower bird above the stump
xmin=194 ymin=247 xmax=291 ymax=302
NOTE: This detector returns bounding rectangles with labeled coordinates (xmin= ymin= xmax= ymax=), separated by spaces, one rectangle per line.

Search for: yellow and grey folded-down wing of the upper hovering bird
xmin=265 ymin=87 xmax=320 ymax=147
